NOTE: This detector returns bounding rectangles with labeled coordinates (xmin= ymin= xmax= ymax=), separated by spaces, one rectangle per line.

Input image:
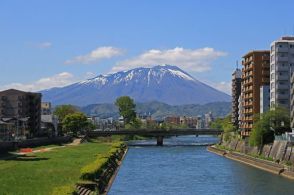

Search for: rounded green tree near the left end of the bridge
xmin=62 ymin=112 xmax=89 ymax=135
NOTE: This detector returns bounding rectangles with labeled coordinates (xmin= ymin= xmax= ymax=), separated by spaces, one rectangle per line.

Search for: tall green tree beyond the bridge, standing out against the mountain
xmin=115 ymin=96 xmax=136 ymax=124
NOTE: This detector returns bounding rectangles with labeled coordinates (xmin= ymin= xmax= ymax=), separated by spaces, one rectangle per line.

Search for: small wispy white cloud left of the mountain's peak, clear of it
xmin=64 ymin=47 xmax=123 ymax=64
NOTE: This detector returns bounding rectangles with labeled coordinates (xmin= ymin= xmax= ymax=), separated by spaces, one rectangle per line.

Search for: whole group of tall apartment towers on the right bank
xmin=232 ymin=36 xmax=294 ymax=137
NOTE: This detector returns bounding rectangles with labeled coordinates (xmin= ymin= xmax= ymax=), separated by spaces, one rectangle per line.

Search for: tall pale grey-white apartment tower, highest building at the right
xmin=270 ymin=37 xmax=294 ymax=110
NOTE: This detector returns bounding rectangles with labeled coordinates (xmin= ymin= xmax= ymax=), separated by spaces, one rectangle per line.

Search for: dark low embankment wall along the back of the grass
xmin=0 ymin=136 xmax=72 ymax=153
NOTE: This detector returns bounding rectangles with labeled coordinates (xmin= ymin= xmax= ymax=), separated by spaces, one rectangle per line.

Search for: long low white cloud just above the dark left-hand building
xmin=1 ymin=72 xmax=76 ymax=91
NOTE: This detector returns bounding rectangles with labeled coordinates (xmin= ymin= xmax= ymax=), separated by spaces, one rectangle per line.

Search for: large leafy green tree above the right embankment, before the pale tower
xmin=249 ymin=107 xmax=291 ymax=146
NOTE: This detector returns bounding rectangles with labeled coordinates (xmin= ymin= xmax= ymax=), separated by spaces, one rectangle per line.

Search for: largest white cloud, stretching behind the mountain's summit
xmin=112 ymin=47 xmax=227 ymax=72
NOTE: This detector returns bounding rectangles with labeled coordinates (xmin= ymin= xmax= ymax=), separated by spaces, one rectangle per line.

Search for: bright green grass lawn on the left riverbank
xmin=0 ymin=141 xmax=118 ymax=194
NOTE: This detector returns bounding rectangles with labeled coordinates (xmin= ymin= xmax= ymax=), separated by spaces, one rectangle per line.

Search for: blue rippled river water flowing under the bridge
xmin=109 ymin=136 xmax=294 ymax=195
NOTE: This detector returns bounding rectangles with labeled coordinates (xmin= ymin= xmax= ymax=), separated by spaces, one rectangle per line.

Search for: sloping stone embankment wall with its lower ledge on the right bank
xmin=208 ymin=140 xmax=294 ymax=179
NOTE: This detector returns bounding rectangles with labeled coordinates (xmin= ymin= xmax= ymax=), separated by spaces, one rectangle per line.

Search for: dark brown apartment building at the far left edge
xmin=0 ymin=89 xmax=42 ymax=133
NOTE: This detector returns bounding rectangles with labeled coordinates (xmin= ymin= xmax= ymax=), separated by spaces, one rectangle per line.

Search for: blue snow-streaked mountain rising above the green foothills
xmin=42 ymin=65 xmax=231 ymax=106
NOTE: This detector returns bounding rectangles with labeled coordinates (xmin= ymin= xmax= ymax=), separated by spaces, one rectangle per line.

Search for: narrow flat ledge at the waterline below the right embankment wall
xmin=207 ymin=146 xmax=294 ymax=180
